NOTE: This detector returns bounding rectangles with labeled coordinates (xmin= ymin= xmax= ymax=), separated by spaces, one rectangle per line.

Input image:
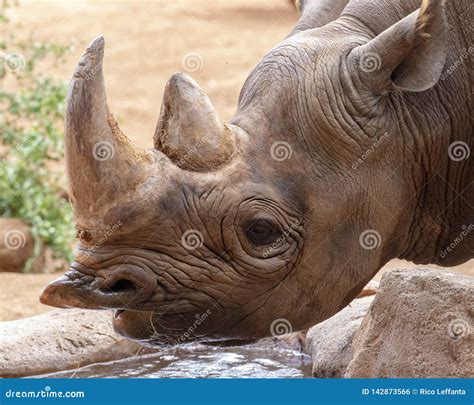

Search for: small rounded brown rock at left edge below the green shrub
xmin=0 ymin=218 xmax=34 ymax=273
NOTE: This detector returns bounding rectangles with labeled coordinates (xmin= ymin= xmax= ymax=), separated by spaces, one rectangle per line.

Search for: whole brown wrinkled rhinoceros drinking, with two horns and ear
xmin=41 ymin=0 xmax=474 ymax=344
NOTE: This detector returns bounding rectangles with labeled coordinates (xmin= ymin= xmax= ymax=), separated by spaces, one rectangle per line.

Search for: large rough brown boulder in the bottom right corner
xmin=345 ymin=269 xmax=474 ymax=378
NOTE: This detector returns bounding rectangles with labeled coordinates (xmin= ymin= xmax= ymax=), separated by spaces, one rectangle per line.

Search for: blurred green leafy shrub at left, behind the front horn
xmin=0 ymin=6 xmax=74 ymax=266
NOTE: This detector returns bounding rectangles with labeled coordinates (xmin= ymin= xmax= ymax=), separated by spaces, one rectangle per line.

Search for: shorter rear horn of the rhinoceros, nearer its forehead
xmin=154 ymin=73 xmax=235 ymax=171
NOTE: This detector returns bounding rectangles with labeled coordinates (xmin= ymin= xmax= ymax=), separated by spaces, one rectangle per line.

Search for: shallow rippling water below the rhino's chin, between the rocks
xmin=38 ymin=345 xmax=311 ymax=378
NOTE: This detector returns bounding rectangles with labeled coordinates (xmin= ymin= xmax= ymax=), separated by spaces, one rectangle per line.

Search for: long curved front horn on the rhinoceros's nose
xmin=65 ymin=37 xmax=149 ymax=222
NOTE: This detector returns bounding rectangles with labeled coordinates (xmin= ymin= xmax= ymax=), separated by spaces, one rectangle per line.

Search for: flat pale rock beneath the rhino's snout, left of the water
xmin=0 ymin=309 xmax=150 ymax=377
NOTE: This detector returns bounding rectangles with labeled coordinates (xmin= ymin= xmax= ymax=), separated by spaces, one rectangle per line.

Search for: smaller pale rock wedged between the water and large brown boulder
xmin=306 ymin=295 xmax=374 ymax=378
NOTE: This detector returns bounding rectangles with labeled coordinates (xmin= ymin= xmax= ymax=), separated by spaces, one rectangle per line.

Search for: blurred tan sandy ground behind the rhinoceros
xmin=0 ymin=0 xmax=474 ymax=320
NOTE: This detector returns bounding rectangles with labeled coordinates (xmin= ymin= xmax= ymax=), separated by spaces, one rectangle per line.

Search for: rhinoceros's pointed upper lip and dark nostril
xmin=40 ymin=266 xmax=156 ymax=309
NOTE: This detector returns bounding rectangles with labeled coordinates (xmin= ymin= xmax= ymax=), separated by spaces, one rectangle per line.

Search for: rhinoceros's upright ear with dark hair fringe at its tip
xmin=349 ymin=0 xmax=447 ymax=93
